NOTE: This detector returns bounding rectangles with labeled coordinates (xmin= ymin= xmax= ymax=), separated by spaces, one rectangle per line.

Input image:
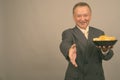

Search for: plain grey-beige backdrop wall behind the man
xmin=0 ymin=0 xmax=120 ymax=80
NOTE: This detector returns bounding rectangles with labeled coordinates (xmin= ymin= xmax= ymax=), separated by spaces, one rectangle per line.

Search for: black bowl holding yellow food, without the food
xmin=93 ymin=40 xmax=117 ymax=46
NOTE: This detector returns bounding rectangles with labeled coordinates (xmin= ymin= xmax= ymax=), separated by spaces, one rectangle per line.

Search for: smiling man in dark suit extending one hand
xmin=60 ymin=2 xmax=113 ymax=80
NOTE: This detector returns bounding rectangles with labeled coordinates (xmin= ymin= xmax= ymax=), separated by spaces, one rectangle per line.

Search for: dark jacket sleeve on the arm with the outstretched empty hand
xmin=60 ymin=29 xmax=73 ymax=60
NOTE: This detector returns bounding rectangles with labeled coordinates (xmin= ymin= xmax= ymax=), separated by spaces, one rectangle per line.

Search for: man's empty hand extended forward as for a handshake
xmin=69 ymin=44 xmax=78 ymax=67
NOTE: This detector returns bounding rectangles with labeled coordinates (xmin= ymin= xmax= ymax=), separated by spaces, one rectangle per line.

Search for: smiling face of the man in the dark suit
xmin=73 ymin=6 xmax=91 ymax=29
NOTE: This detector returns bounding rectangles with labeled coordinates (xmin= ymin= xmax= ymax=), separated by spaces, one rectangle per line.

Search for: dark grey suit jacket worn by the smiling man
xmin=60 ymin=27 xmax=113 ymax=80
